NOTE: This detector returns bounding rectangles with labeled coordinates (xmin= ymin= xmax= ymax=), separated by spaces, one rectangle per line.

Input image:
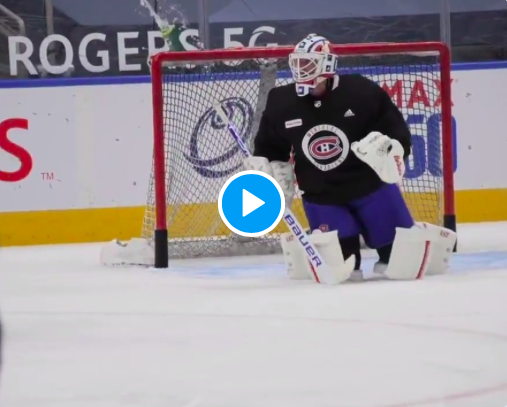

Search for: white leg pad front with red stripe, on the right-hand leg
xmin=385 ymin=227 xmax=434 ymax=280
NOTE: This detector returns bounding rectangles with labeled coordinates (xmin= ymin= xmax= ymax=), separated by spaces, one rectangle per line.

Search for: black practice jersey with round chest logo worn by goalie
xmin=254 ymin=75 xmax=411 ymax=205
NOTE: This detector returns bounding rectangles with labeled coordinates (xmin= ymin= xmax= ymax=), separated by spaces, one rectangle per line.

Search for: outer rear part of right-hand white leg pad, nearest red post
xmin=417 ymin=222 xmax=458 ymax=275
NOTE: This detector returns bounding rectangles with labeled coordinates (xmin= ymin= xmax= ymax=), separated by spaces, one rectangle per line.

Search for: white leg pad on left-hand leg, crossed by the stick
xmin=280 ymin=231 xmax=355 ymax=282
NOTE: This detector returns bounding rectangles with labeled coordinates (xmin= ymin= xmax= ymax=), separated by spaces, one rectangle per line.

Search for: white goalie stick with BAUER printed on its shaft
xmin=213 ymin=102 xmax=354 ymax=285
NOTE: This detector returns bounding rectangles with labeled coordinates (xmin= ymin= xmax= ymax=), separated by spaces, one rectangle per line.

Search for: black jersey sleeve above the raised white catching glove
xmin=374 ymin=85 xmax=412 ymax=158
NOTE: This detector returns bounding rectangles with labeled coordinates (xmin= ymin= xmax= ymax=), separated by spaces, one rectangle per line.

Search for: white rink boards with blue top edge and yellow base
xmin=0 ymin=60 xmax=507 ymax=246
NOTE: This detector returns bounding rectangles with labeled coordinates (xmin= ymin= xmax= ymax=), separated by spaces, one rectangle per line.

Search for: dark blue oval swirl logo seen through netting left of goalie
xmin=185 ymin=97 xmax=254 ymax=178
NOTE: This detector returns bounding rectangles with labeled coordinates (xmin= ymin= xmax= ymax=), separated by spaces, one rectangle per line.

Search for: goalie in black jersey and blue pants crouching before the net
xmin=245 ymin=34 xmax=456 ymax=279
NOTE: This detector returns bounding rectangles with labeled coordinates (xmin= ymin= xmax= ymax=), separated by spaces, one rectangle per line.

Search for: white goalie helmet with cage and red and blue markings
xmin=289 ymin=34 xmax=338 ymax=96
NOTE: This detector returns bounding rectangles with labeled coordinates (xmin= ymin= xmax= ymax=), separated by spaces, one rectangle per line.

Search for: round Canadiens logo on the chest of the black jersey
xmin=302 ymin=124 xmax=350 ymax=171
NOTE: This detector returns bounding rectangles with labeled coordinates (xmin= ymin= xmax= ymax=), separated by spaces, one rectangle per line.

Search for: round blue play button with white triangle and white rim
xmin=218 ymin=171 xmax=285 ymax=237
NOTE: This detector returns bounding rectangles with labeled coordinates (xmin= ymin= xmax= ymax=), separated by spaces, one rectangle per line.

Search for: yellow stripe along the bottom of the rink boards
xmin=0 ymin=189 xmax=507 ymax=247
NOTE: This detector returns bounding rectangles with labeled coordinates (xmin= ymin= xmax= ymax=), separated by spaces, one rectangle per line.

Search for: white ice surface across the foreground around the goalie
xmin=0 ymin=223 xmax=507 ymax=407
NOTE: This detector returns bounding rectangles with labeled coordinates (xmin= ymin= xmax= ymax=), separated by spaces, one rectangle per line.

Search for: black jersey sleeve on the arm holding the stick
xmin=253 ymin=92 xmax=292 ymax=162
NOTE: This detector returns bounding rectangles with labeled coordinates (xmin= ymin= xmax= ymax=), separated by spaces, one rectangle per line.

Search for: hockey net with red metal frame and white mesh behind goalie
xmin=142 ymin=43 xmax=454 ymax=267
